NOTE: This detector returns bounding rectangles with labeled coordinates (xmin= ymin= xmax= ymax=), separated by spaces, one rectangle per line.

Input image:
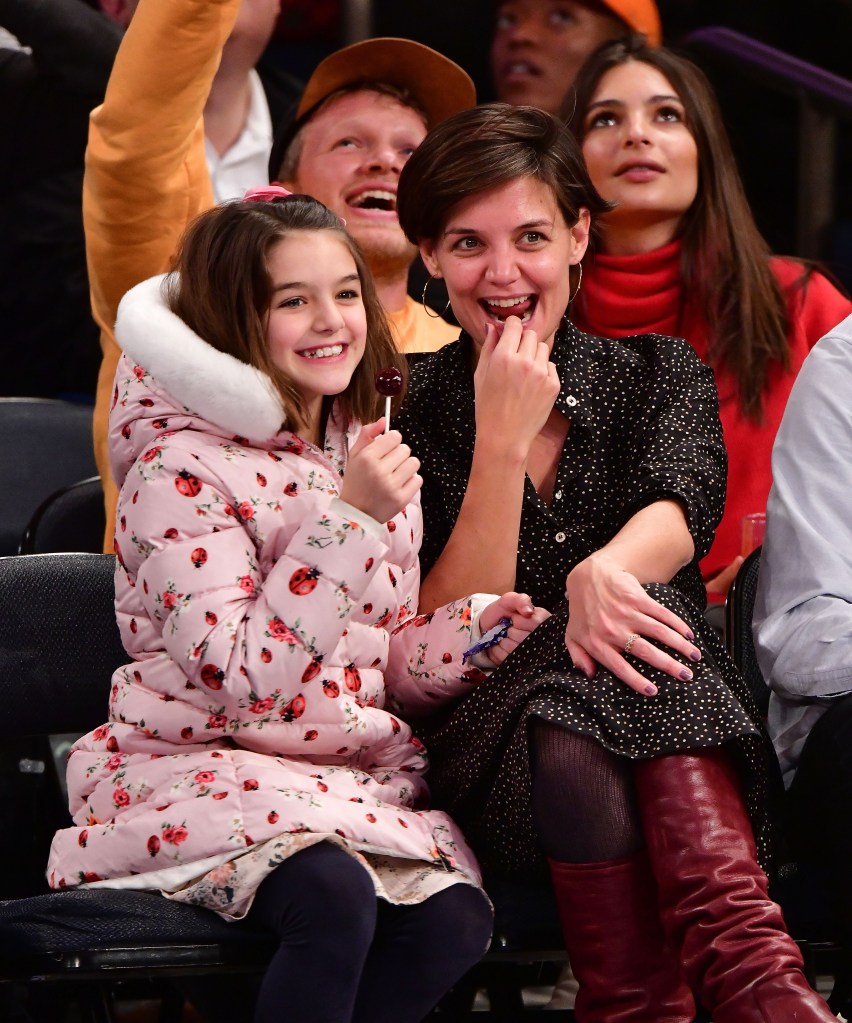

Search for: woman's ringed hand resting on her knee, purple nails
xmin=565 ymin=551 xmax=701 ymax=697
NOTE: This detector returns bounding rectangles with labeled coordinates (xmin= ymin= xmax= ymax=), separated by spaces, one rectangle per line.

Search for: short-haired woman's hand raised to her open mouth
xmin=474 ymin=316 xmax=559 ymax=458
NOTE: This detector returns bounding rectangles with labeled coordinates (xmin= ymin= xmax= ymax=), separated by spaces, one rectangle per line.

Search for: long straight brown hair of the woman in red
xmin=564 ymin=35 xmax=797 ymax=421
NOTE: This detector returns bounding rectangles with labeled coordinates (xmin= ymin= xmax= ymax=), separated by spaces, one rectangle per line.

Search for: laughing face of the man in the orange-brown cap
xmin=287 ymin=90 xmax=427 ymax=276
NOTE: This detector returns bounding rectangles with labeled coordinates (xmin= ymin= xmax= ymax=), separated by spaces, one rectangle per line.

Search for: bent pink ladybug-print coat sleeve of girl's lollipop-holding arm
xmin=117 ymin=445 xmax=388 ymax=720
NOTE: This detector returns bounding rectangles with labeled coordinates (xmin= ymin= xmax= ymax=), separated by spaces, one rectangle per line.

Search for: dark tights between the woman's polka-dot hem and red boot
xmin=531 ymin=718 xmax=643 ymax=863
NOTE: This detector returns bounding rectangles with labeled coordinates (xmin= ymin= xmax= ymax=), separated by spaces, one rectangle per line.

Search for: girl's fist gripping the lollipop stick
xmin=341 ymin=418 xmax=423 ymax=522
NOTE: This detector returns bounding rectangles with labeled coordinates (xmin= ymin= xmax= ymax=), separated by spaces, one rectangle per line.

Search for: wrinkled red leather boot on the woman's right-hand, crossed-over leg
xmin=635 ymin=749 xmax=837 ymax=1023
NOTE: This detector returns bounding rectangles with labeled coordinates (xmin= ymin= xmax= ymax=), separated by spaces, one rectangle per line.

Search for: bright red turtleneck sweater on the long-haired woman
xmin=573 ymin=241 xmax=852 ymax=579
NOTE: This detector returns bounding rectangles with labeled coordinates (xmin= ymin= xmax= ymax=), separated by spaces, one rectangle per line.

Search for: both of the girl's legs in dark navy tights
xmin=242 ymin=842 xmax=492 ymax=1023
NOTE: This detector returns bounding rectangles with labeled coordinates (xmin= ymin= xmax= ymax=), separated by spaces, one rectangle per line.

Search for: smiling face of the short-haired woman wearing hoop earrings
xmin=420 ymin=177 xmax=589 ymax=346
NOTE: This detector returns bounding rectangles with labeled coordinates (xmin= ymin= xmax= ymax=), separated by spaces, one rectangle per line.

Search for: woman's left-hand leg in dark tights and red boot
xmin=532 ymin=719 xmax=694 ymax=1023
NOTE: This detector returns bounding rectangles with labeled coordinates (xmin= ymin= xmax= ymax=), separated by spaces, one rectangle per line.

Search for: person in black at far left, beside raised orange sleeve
xmin=0 ymin=0 xmax=126 ymax=401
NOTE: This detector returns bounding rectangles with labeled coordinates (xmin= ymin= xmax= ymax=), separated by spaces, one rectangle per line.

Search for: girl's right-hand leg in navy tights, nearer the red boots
xmin=352 ymin=884 xmax=492 ymax=1023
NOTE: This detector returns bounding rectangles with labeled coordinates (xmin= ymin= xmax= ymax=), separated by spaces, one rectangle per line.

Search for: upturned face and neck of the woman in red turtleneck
xmin=583 ymin=60 xmax=699 ymax=253
